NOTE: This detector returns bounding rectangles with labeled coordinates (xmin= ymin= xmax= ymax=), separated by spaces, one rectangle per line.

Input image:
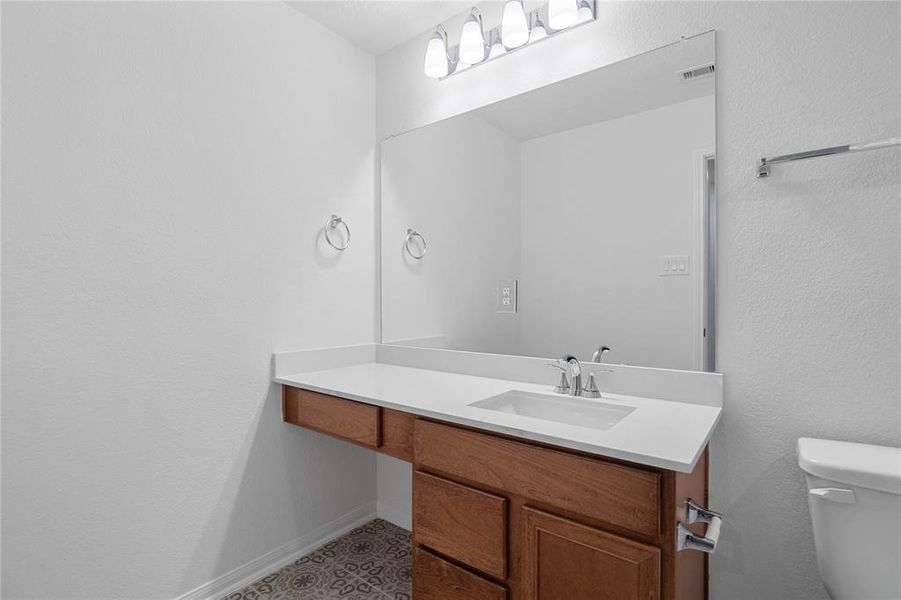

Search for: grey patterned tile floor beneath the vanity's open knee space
xmin=223 ymin=519 xmax=413 ymax=600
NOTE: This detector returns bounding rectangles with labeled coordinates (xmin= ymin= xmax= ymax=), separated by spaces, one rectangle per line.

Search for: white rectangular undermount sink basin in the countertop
xmin=469 ymin=390 xmax=635 ymax=430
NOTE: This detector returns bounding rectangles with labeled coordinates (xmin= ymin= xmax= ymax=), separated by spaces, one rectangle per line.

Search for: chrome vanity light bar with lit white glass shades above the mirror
xmin=423 ymin=0 xmax=597 ymax=79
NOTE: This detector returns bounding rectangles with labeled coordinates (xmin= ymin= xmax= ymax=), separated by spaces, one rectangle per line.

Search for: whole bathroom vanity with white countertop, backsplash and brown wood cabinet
xmin=276 ymin=345 xmax=722 ymax=600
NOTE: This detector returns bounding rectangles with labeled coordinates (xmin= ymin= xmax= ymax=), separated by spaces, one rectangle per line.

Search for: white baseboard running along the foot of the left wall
xmin=175 ymin=502 xmax=376 ymax=600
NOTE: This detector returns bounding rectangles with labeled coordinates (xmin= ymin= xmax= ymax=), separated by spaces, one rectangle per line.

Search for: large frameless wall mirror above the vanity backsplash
xmin=382 ymin=33 xmax=715 ymax=370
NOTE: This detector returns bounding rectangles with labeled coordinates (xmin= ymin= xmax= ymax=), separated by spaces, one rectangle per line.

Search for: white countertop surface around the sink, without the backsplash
xmin=274 ymin=362 xmax=722 ymax=473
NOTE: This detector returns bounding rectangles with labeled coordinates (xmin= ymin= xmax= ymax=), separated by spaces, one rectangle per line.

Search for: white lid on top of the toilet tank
xmin=798 ymin=438 xmax=901 ymax=494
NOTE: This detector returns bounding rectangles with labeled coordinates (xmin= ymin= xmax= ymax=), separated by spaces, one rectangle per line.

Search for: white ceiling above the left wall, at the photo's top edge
xmin=288 ymin=0 xmax=473 ymax=55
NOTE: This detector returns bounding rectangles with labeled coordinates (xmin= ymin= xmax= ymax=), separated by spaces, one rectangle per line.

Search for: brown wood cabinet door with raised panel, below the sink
xmin=522 ymin=507 xmax=660 ymax=600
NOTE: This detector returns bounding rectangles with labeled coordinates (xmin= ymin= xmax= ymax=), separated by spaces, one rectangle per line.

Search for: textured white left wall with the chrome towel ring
xmin=2 ymin=2 xmax=376 ymax=600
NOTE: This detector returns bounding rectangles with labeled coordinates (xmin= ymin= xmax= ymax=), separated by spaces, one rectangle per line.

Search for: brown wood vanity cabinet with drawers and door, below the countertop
xmin=283 ymin=387 xmax=707 ymax=600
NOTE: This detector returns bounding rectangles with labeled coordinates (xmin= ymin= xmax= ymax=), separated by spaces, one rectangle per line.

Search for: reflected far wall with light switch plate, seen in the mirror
xmin=519 ymin=96 xmax=715 ymax=369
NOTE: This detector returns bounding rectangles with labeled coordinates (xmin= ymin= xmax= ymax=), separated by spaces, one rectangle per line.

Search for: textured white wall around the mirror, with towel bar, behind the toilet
xmin=377 ymin=2 xmax=901 ymax=600
